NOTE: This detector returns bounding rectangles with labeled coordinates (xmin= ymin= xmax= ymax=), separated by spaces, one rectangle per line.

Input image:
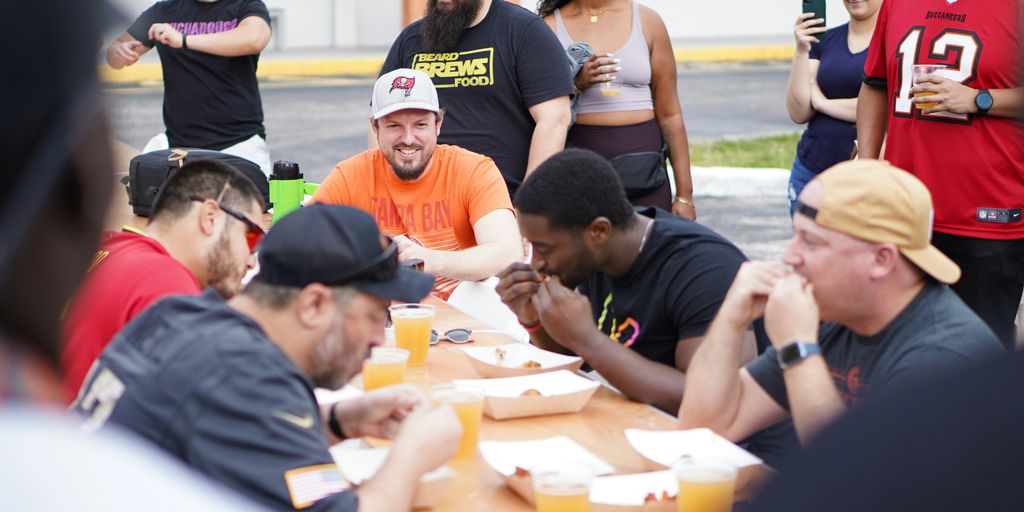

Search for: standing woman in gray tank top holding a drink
xmin=538 ymin=0 xmax=696 ymax=220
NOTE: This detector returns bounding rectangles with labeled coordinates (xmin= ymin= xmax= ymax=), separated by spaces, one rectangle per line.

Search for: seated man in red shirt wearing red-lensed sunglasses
xmin=60 ymin=160 xmax=263 ymax=401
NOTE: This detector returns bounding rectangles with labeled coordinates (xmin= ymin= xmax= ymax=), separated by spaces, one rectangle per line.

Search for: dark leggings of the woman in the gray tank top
xmin=566 ymin=119 xmax=672 ymax=211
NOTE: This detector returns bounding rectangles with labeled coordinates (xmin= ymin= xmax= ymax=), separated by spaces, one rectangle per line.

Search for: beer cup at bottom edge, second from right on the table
xmin=529 ymin=462 xmax=596 ymax=512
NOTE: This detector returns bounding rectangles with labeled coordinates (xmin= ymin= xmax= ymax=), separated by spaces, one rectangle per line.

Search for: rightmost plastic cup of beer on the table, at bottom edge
xmin=672 ymin=457 xmax=736 ymax=512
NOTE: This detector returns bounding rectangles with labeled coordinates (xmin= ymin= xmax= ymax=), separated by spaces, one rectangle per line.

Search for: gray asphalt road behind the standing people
xmin=106 ymin=63 xmax=799 ymax=259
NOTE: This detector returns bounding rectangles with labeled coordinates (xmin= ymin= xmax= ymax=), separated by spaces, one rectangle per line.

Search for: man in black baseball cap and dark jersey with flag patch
xmin=72 ymin=205 xmax=462 ymax=511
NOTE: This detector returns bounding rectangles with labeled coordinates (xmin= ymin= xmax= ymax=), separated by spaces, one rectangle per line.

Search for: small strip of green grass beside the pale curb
xmin=690 ymin=133 xmax=800 ymax=169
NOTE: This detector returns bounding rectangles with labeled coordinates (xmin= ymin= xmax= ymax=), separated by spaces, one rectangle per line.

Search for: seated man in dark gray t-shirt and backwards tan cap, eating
xmin=679 ymin=160 xmax=1001 ymax=443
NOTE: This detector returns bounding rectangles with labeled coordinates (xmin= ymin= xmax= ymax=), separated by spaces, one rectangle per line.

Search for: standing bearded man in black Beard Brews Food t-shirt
xmin=370 ymin=0 xmax=573 ymax=194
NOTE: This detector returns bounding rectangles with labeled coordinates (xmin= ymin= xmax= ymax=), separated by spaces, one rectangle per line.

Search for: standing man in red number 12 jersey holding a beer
xmin=857 ymin=0 xmax=1024 ymax=348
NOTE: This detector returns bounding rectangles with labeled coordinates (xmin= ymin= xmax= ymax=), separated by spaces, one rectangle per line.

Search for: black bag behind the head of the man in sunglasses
xmin=121 ymin=147 xmax=270 ymax=217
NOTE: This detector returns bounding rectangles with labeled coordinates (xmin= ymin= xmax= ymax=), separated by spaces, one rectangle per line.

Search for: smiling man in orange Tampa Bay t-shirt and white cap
xmin=313 ymin=69 xmax=523 ymax=300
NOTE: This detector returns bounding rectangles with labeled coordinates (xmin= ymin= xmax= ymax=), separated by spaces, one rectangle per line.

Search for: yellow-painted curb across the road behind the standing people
xmin=99 ymin=45 xmax=793 ymax=84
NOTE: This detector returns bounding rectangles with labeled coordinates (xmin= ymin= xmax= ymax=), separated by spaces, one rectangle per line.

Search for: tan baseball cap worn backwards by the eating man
xmin=797 ymin=160 xmax=961 ymax=284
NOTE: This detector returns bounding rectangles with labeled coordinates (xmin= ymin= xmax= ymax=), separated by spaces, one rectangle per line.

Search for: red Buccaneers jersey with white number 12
xmin=864 ymin=0 xmax=1024 ymax=240
